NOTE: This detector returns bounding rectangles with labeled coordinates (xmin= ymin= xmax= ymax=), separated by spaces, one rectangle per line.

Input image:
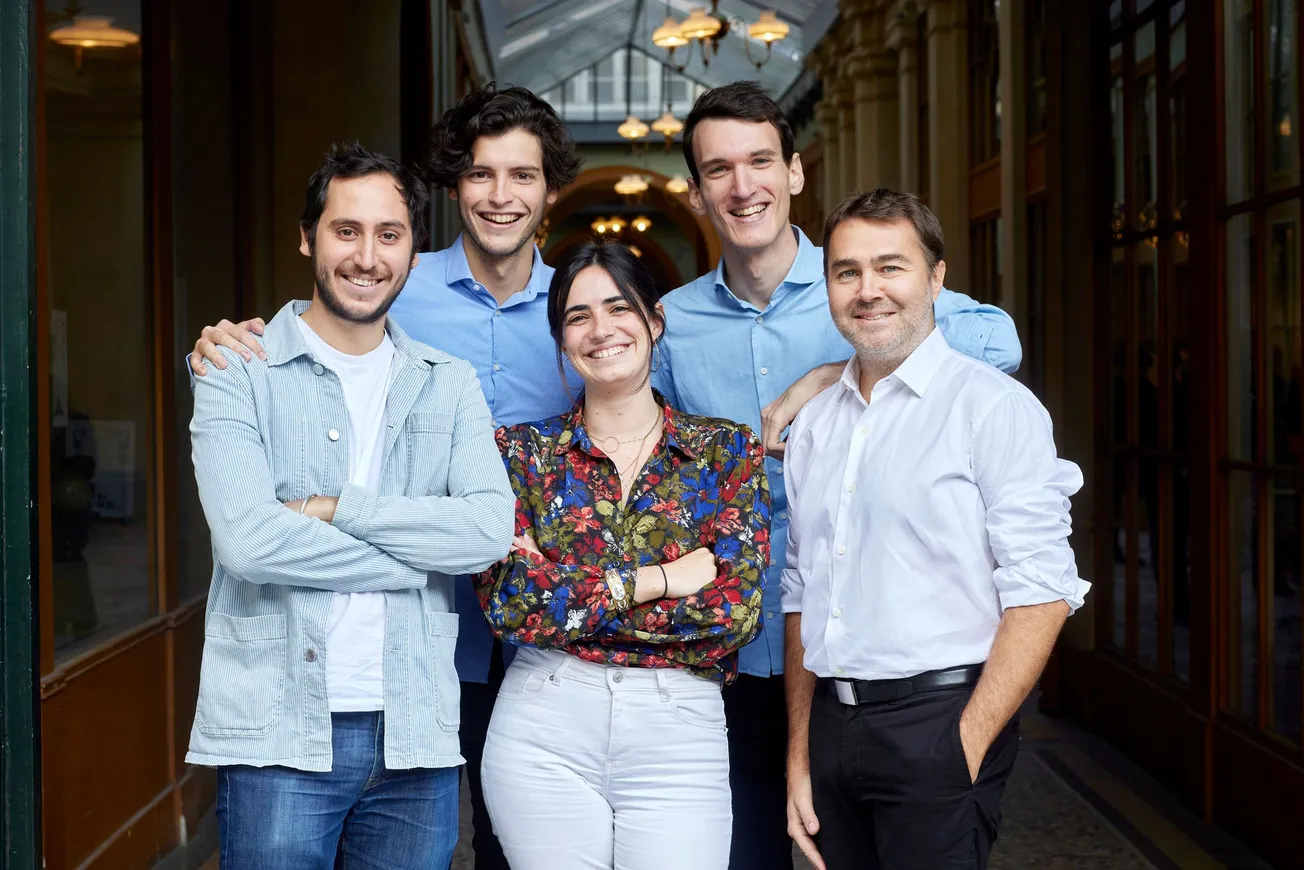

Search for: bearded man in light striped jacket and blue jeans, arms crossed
xmin=186 ymin=145 xmax=514 ymax=870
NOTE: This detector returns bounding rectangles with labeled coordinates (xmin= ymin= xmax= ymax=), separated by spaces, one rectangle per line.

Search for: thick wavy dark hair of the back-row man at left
xmin=425 ymin=82 xmax=579 ymax=190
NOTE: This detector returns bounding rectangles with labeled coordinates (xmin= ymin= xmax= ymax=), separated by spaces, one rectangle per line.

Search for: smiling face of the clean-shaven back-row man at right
xmin=689 ymin=119 xmax=806 ymax=250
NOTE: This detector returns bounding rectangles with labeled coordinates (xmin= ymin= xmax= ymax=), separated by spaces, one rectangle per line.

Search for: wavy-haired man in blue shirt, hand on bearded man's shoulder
xmin=190 ymin=85 xmax=579 ymax=870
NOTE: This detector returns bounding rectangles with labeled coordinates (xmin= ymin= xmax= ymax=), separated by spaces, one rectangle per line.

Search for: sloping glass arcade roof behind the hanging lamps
xmin=494 ymin=0 xmax=822 ymax=98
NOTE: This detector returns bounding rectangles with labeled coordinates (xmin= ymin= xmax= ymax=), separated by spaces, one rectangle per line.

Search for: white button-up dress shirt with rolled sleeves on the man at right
xmin=782 ymin=329 xmax=1090 ymax=680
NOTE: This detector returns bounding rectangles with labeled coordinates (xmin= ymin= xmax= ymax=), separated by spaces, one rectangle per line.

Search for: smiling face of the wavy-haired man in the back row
xmin=449 ymin=128 xmax=557 ymax=258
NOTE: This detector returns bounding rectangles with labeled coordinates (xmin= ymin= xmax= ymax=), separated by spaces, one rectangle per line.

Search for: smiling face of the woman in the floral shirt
xmin=562 ymin=266 xmax=661 ymax=391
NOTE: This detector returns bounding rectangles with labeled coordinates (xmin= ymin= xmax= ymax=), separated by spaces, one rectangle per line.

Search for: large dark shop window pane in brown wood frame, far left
xmin=42 ymin=3 xmax=156 ymax=659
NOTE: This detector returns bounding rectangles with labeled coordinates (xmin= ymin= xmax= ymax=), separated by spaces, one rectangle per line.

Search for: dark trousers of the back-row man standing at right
xmin=724 ymin=674 xmax=793 ymax=870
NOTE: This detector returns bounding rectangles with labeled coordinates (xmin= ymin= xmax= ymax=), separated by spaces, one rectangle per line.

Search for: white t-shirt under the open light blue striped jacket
xmin=297 ymin=317 xmax=394 ymax=712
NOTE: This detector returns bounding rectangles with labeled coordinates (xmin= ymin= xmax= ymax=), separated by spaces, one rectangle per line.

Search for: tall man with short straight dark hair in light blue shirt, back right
xmin=653 ymin=82 xmax=1021 ymax=870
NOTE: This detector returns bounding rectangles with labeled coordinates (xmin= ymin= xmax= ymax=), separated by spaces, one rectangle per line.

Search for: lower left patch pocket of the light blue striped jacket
xmin=196 ymin=613 xmax=287 ymax=736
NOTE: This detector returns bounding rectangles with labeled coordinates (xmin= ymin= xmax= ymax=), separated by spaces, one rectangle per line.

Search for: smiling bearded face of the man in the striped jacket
xmin=299 ymin=172 xmax=416 ymax=323
